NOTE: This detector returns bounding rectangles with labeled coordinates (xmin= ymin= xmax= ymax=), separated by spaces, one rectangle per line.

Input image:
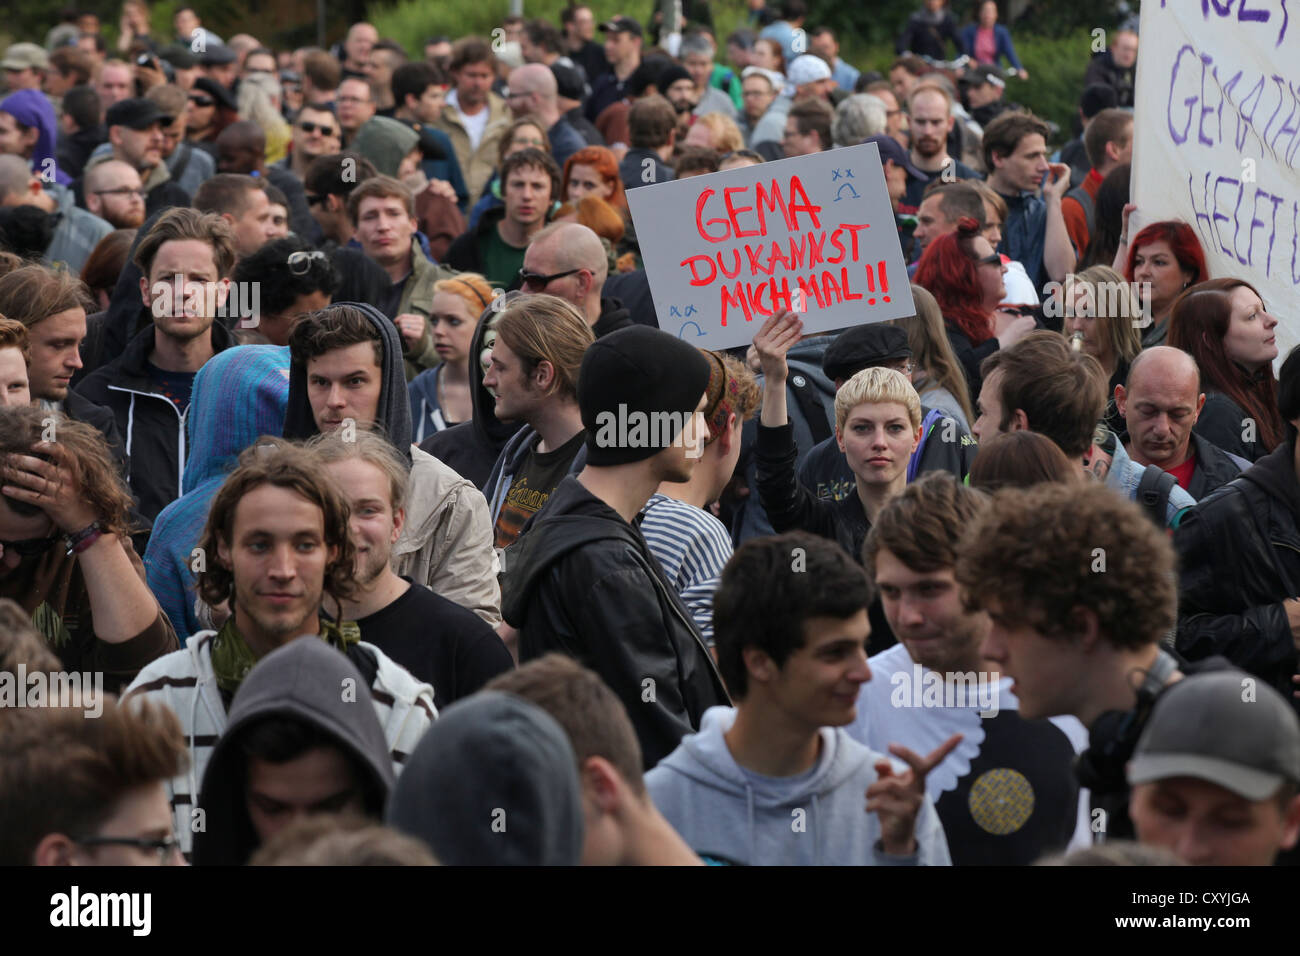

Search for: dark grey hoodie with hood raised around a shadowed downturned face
xmin=194 ymin=637 xmax=394 ymax=866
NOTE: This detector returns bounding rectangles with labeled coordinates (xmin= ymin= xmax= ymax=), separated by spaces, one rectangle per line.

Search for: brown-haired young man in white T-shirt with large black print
xmin=848 ymin=473 xmax=1088 ymax=866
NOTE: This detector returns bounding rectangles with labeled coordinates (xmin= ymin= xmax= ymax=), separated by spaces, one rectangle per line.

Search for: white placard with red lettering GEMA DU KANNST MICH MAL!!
xmin=628 ymin=143 xmax=915 ymax=349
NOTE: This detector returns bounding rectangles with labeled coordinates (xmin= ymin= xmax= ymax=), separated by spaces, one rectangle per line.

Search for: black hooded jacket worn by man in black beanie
xmin=502 ymin=476 xmax=729 ymax=769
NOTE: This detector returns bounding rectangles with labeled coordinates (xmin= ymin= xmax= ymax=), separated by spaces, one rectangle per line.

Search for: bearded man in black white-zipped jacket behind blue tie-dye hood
xmin=77 ymin=208 xmax=235 ymax=538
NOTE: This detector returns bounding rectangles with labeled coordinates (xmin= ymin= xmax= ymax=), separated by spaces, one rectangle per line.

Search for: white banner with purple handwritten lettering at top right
xmin=1128 ymin=0 xmax=1300 ymax=362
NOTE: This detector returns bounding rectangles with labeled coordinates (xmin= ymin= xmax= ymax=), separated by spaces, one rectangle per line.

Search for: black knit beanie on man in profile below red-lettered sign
xmin=577 ymin=325 xmax=709 ymax=467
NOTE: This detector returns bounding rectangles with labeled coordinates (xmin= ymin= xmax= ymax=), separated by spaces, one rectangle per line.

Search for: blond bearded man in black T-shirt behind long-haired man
xmin=312 ymin=431 xmax=515 ymax=710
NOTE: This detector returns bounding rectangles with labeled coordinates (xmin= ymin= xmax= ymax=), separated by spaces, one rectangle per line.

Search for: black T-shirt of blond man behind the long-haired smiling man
xmin=356 ymin=578 xmax=515 ymax=710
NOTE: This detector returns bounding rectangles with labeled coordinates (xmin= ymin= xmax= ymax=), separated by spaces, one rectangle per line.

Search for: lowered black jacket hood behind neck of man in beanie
xmin=501 ymin=475 xmax=645 ymax=620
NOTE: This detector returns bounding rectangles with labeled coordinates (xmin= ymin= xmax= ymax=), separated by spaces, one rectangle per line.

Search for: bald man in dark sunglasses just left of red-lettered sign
xmin=519 ymin=222 xmax=633 ymax=338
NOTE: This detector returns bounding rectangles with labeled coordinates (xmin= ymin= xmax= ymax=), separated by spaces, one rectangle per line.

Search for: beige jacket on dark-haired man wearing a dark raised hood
xmin=393 ymin=447 xmax=501 ymax=627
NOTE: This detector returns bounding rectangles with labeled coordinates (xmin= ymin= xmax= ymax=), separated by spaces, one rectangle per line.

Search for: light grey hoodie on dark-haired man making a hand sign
xmin=645 ymin=708 xmax=952 ymax=866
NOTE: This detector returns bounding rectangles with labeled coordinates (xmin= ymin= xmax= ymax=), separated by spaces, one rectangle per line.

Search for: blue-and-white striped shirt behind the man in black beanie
xmin=641 ymin=493 xmax=732 ymax=646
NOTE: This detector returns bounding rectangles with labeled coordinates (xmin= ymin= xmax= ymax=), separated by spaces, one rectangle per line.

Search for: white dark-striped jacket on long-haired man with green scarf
xmin=124 ymin=631 xmax=438 ymax=857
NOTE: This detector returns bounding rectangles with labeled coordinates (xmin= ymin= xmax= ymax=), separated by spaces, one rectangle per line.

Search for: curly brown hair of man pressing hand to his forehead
xmin=0 ymin=407 xmax=135 ymax=537
